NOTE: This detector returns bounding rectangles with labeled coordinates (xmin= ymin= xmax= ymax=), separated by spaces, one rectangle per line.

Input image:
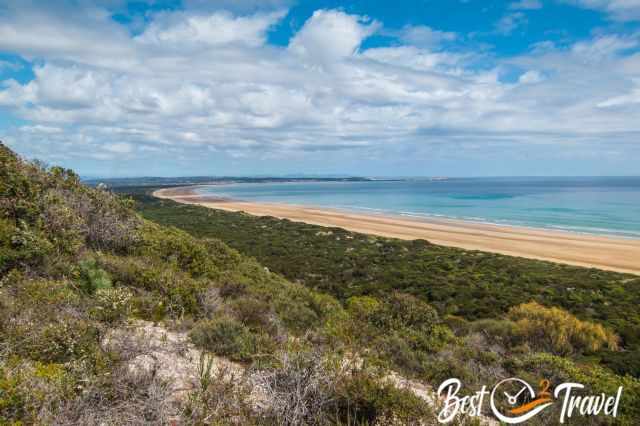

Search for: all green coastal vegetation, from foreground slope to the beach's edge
xmin=0 ymin=145 xmax=640 ymax=425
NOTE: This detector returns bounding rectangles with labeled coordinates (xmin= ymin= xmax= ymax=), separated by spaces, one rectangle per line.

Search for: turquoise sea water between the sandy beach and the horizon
xmin=200 ymin=177 xmax=640 ymax=238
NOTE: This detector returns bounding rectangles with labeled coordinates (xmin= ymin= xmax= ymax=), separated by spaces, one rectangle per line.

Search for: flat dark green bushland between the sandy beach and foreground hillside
xmin=129 ymin=187 xmax=640 ymax=377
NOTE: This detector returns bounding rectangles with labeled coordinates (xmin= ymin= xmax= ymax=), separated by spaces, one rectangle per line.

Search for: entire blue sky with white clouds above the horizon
xmin=0 ymin=0 xmax=640 ymax=177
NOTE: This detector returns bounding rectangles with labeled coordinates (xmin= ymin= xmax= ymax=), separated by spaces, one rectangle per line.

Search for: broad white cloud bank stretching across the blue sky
xmin=0 ymin=2 xmax=640 ymax=175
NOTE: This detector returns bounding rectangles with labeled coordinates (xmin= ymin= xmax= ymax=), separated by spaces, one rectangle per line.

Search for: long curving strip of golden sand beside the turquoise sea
xmin=153 ymin=187 xmax=640 ymax=275
